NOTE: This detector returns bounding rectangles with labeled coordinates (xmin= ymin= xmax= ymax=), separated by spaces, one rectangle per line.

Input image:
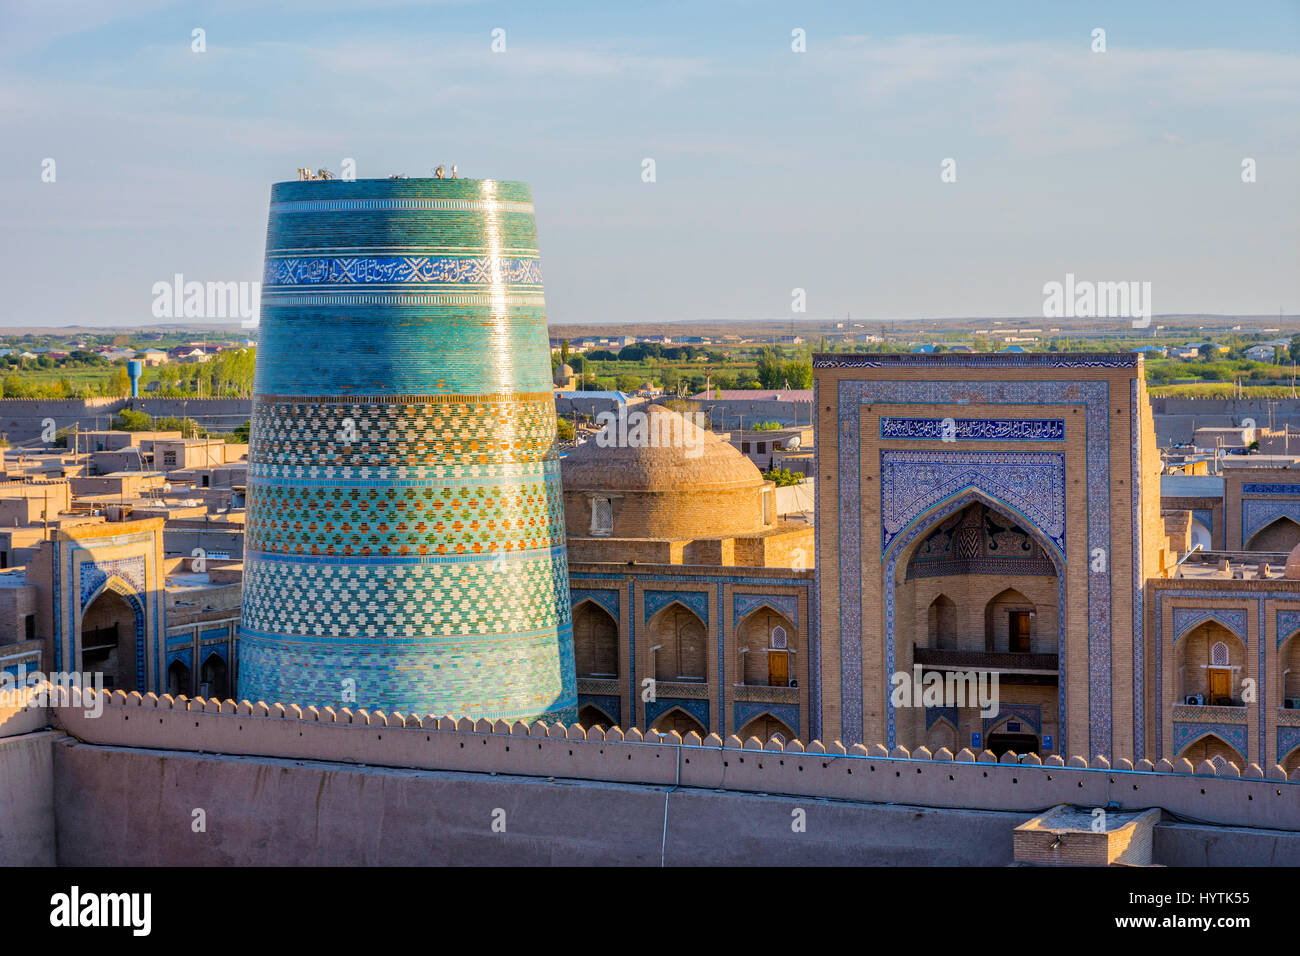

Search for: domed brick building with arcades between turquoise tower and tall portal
xmin=560 ymin=405 xmax=815 ymax=740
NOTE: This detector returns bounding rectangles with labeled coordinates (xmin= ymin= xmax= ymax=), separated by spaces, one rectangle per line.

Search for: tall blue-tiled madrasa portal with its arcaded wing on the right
xmin=810 ymin=352 xmax=1300 ymax=770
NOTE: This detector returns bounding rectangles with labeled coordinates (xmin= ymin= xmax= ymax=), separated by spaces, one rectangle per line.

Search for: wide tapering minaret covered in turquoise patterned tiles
xmin=239 ymin=178 xmax=576 ymax=723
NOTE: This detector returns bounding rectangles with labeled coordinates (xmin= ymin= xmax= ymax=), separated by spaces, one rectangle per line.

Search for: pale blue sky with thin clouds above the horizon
xmin=0 ymin=0 xmax=1300 ymax=325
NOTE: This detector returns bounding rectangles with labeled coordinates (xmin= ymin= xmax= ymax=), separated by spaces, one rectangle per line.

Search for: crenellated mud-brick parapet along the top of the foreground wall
xmin=0 ymin=691 xmax=1300 ymax=830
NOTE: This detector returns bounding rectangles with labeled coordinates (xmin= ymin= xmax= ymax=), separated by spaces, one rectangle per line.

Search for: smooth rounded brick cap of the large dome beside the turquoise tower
xmin=560 ymin=405 xmax=763 ymax=492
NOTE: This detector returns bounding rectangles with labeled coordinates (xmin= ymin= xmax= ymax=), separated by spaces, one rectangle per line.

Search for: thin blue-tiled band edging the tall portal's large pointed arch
xmin=880 ymin=485 xmax=1069 ymax=750
